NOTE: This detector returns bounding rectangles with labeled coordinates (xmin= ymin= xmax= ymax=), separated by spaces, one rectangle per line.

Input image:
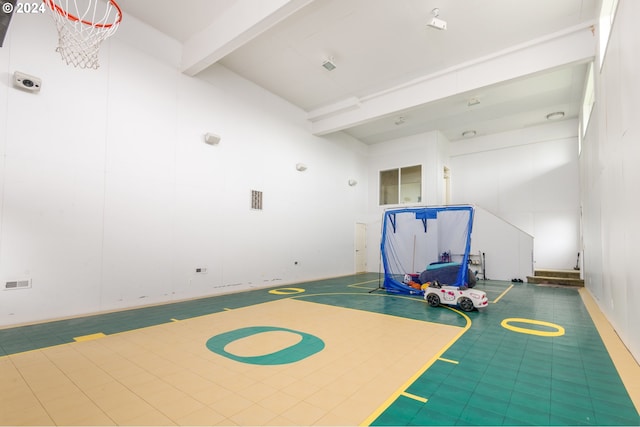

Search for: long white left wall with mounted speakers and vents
xmin=0 ymin=11 xmax=368 ymax=325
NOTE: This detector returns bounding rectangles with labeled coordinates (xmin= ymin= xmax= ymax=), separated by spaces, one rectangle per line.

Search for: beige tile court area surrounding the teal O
xmin=0 ymin=299 xmax=462 ymax=425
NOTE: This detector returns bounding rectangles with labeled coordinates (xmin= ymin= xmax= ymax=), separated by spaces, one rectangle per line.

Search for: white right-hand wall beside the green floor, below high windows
xmin=580 ymin=0 xmax=640 ymax=361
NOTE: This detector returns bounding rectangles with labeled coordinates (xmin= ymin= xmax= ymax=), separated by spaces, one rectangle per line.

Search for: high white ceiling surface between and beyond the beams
xmin=118 ymin=0 xmax=597 ymax=144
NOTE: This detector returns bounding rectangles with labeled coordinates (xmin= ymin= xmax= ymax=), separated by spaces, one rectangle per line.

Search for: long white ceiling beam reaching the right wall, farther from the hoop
xmin=307 ymin=23 xmax=596 ymax=135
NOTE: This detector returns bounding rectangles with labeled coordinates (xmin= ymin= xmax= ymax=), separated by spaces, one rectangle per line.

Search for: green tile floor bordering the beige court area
xmin=0 ymin=273 xmax=640 ymax=426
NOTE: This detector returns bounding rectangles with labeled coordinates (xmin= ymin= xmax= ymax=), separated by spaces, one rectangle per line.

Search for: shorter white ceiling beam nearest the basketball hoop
xmin=181 ymin=0 xmax=313 ymax=76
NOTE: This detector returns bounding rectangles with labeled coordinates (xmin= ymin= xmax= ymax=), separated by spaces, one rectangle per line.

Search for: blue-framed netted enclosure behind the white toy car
xmin=380 ymin=205 xmax=474 ymax=295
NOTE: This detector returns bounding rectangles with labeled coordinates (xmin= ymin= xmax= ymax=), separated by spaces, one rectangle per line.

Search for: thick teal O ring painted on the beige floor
xmin=207 ymin=326 xmax=324 ymax=365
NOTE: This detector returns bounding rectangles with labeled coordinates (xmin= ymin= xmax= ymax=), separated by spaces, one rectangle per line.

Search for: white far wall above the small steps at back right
xmin=450 ymin=120 xmax=580 ymax=270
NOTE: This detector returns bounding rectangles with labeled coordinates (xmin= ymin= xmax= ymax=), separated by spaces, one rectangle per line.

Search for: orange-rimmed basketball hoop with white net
xmin=43 ymin=0 xmax=122 ymax=69
